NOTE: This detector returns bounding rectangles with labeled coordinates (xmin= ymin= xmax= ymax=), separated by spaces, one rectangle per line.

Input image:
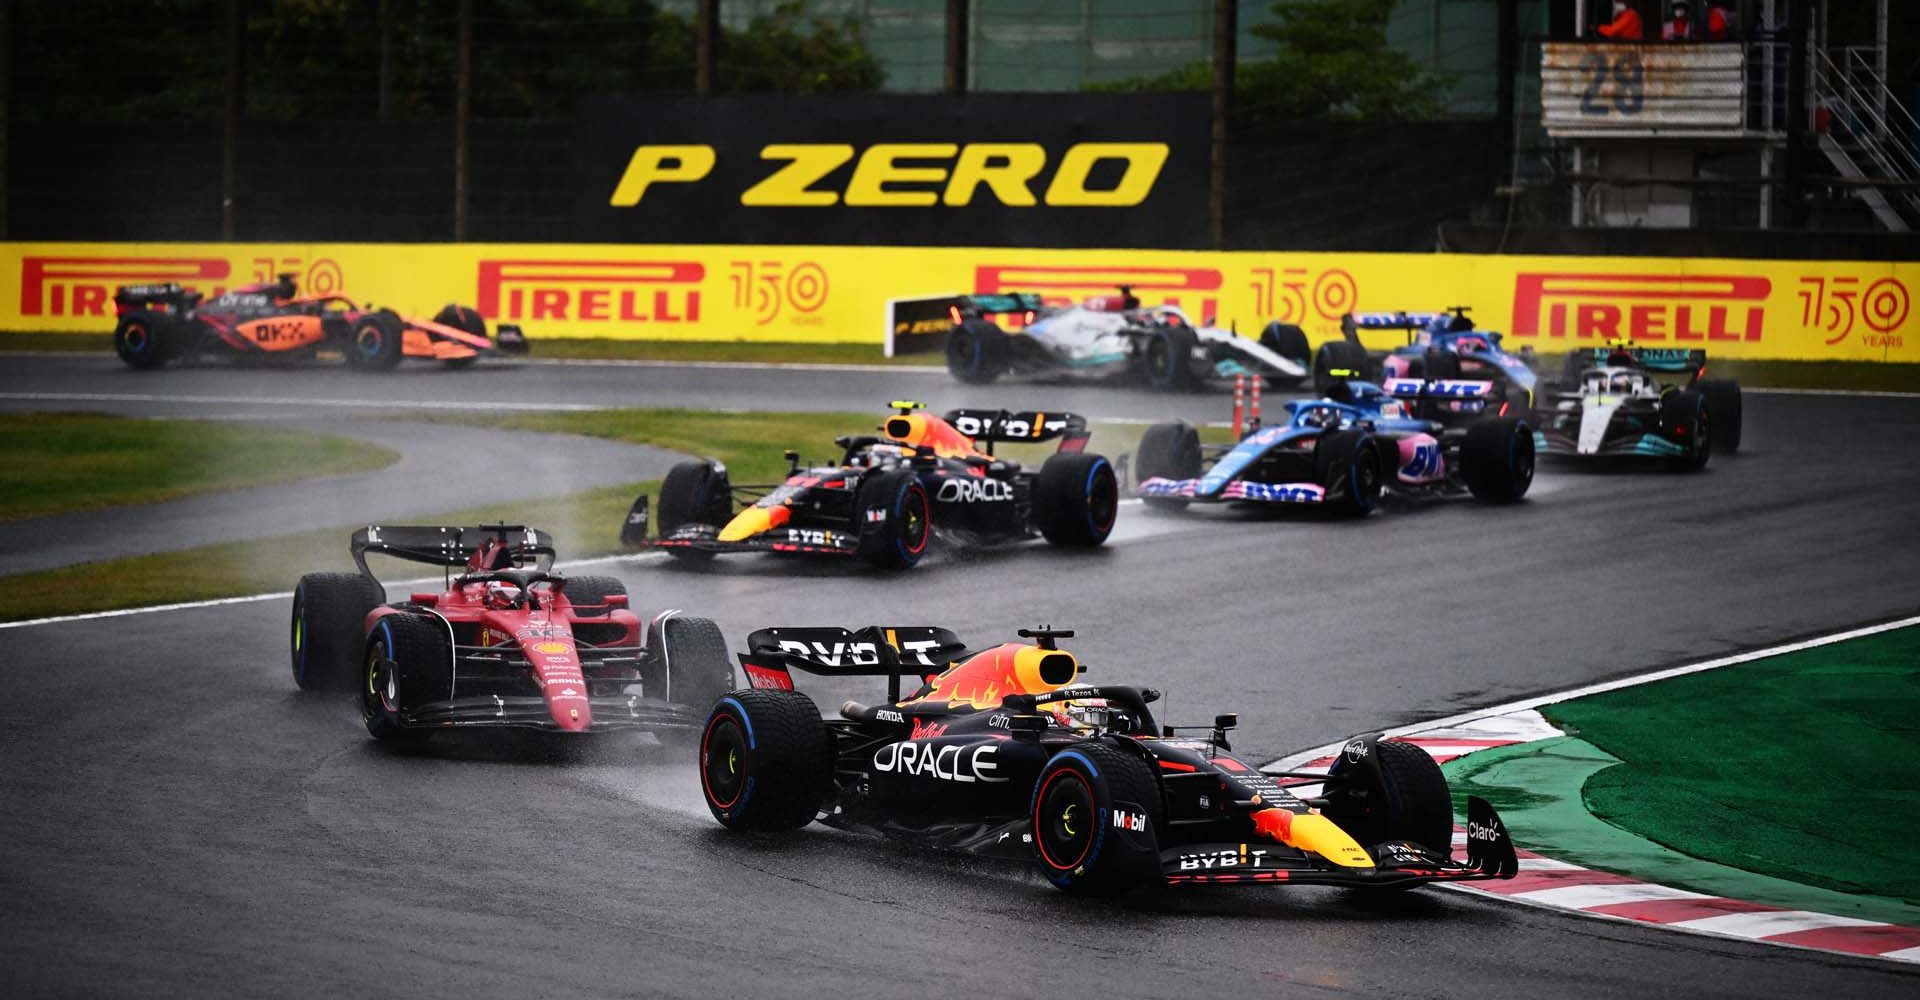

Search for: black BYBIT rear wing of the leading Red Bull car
xmin=739 ymin=626 xmax=968 ymax=701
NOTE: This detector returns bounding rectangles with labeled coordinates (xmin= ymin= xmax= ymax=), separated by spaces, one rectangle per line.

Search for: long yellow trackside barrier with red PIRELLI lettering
xmin=0 ymin=244 xmax=1920 ymax=361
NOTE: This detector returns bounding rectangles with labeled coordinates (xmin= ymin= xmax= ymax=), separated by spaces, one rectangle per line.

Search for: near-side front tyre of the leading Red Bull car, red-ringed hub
xmin=1027 ymin=741 xmax=1164 ymax=896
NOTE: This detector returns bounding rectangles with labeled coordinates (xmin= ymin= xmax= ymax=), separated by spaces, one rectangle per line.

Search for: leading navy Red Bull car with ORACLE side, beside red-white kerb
xmin=699 ymin=626 xmax=1519 ymax=894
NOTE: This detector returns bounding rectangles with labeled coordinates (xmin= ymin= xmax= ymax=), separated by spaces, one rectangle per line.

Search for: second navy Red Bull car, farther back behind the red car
xmin=620 ymin=401 xmax=1119 ymax=568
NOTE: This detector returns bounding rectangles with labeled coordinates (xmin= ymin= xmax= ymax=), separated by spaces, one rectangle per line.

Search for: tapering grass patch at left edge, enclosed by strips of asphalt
xmin=0 ymin=413 xmax=399 ymax=520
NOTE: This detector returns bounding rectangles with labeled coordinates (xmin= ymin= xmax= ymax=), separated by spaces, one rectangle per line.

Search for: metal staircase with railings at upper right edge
xmin=1812 ymin=46 xmax=1920 ymax=232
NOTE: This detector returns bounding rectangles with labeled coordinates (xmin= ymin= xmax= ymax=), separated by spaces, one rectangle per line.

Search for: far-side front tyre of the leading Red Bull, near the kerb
xmin=1325 ymin=739 xmax=1453 ymax=856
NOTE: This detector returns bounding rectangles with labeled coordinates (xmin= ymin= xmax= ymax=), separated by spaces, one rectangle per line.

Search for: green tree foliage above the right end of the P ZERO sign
xmin=1091 ymin=0 xmax=1446 ymax=121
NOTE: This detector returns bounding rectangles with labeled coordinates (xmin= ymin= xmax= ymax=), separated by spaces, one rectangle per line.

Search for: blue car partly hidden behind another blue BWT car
xmin=1313 ymin=305 xmax=1540 ymax=412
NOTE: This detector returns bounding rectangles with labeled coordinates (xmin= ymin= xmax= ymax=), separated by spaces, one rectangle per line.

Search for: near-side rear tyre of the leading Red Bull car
xmin=699 ymin=689 xmax=833 ymax=831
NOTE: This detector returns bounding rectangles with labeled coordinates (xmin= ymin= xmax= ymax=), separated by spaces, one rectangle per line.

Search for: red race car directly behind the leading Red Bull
xmin=292 ymin=524 xmax=733 ymax=741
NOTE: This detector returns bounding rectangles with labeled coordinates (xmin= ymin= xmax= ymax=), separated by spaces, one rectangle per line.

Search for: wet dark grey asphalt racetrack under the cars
xmin=0 ymin=355 xmax=1920 ymax=998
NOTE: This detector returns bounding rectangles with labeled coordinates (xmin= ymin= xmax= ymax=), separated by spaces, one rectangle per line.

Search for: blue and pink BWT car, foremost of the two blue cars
xmin=1135 ymin=378 xmax=1534 ymax=514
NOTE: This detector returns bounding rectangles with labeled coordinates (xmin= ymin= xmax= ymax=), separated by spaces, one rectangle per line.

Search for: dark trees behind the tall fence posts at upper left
xmin=12 ymin=0 xmax=883 ymax=121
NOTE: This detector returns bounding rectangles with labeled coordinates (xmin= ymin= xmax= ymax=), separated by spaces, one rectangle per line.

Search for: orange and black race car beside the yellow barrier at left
xmin=113 ymin=274 xmax=526 ymax=369
